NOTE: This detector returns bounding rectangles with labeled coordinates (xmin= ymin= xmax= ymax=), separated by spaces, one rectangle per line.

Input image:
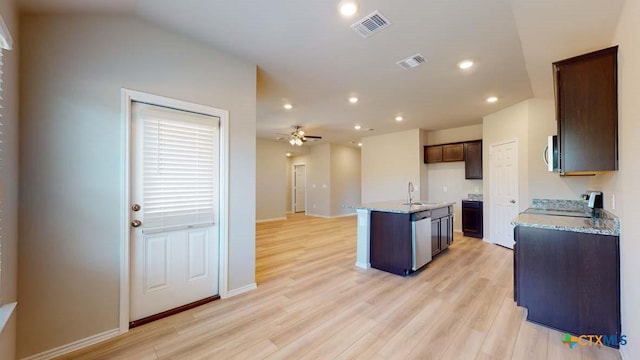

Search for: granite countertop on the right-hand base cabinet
xmin=511 ymin=210 xmax=620 ymax=236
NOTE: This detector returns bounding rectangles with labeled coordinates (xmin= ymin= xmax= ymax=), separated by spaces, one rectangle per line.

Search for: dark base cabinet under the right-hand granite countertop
xmin=514 ymin=226 xmax=621 ymax=347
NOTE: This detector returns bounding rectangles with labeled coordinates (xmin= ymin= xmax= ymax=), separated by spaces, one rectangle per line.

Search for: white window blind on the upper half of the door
xmin=139 ymin=105 xmax=219 ymax=233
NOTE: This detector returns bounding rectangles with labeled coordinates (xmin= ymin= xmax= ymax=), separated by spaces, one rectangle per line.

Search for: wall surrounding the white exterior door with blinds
xmin=18 ymin=15 xmax=256 ymax=357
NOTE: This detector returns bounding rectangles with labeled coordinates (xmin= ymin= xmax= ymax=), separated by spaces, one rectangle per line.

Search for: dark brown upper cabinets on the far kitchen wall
xmin=424 ymin=140 xmax=482 ymax=179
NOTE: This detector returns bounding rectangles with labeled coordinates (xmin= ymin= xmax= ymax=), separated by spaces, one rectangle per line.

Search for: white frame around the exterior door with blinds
xmin=119 ymin=88 xmax=229 ymax=334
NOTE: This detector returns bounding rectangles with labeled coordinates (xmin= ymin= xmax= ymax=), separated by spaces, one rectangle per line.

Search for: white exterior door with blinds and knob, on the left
xmin=130 ymin=102 xmax=219 ymax=321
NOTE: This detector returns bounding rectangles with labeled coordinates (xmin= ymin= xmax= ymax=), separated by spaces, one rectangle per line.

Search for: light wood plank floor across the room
xmin=62 ymin=214 xmax=619 ymax=360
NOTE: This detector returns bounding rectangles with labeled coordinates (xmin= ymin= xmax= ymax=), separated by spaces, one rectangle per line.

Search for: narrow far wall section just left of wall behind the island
xmin=331 ymin=144 xmax=361 ymax=216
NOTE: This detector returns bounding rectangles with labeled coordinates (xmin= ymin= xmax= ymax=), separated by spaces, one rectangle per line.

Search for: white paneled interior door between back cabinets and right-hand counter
xmin=489 ymin=140 xmax=519 ymax=249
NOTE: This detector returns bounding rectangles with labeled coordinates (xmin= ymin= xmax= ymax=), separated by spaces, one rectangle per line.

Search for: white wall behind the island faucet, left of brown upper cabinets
xmin=361 ymin=129 xmax=424 ymax=203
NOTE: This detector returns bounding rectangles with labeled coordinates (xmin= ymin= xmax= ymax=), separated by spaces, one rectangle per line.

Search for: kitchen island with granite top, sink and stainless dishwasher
xmin=353 ymin=200 xmax=455 ymax=275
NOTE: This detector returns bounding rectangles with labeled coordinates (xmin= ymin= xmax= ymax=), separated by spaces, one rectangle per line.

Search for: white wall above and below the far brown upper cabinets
xmin=423 ymin=124 xmax=484 ymax=231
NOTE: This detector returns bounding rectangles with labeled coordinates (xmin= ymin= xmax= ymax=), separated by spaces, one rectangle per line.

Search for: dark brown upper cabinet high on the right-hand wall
xmin=553 ymin=46 xmax=618 ymax=175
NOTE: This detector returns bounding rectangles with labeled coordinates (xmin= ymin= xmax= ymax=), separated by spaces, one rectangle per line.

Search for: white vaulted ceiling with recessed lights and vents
xmin=19 ymin=0 xmax=624 ymax=143
